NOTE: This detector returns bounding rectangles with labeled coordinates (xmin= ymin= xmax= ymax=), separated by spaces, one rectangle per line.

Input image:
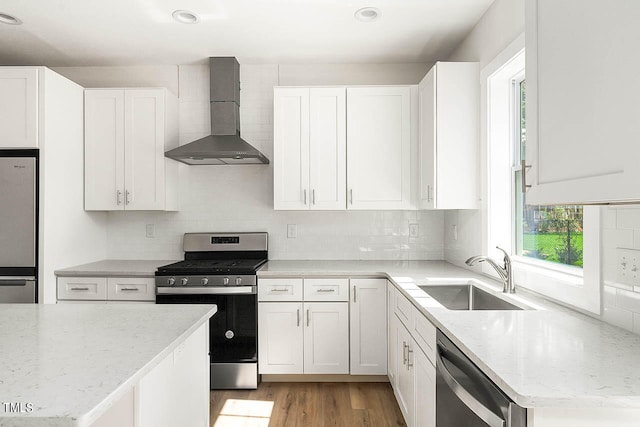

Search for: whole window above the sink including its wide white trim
xmin=484 ymin=34 xmax=601 ymax=314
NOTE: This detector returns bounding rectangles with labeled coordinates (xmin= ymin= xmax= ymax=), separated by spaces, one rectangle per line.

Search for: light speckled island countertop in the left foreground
xmin=0 ymin=304 xmax=216 ymax=427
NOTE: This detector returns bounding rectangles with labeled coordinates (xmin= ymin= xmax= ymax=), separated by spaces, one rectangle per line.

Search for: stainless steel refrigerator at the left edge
xmin=0 ymin=149 xmax=38 ymax=303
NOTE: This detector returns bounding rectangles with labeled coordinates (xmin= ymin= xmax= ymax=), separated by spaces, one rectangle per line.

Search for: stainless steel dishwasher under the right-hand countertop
xmin=436 ymin=331 xmax=527 ymax=427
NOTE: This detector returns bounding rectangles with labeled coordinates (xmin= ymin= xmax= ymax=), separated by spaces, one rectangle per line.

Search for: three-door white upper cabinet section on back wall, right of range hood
xmin=273 ymin=86 xmax=411 ymax=210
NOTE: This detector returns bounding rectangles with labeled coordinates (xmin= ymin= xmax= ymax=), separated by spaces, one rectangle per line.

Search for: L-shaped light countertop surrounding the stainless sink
xmin=258 ymin=261 xmax=640 ymax=408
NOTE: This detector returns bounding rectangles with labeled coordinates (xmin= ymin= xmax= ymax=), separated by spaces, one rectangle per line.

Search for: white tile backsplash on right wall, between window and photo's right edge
xmin=602 ymin=206 xmax=640 ymax=334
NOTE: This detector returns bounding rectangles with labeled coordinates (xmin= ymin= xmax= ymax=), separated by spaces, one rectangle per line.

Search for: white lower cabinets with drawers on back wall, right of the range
xmin=258 ymin=277 xmax=387 ymax=375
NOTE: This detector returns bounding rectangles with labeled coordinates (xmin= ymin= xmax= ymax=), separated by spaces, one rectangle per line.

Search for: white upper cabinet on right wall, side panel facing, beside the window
xmin=418 ymin=62 xmax=480 ymax=209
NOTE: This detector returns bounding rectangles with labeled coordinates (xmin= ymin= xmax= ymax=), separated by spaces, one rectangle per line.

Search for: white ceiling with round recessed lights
xmin=0 ymin=0 xmax=493 ymax=66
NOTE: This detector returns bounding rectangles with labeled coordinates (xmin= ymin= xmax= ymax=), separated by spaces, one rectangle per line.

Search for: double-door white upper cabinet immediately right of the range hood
xmin=273 ymin=87 xmax=346 ymax=210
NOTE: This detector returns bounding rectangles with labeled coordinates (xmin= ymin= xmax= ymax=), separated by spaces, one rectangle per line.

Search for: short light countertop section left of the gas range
xmin=54 ymin=259 xmax=177 ymax=277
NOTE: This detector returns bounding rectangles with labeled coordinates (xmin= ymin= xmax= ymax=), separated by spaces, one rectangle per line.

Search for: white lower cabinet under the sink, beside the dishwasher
xmin=388 ymin=284 xmax=436 ymax=427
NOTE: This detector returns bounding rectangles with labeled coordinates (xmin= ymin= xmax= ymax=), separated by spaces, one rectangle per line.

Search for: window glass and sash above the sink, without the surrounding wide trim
xmin=512 ymin=75 xmax=583 ymax=268
